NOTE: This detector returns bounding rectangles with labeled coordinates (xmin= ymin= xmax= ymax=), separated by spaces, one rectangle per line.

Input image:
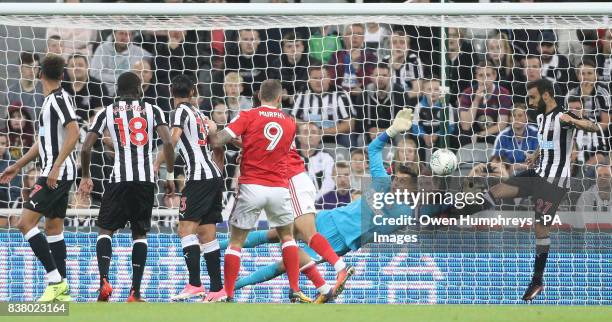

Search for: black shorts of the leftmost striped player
xmin=23 ymin=177 xmax=74 ymax=218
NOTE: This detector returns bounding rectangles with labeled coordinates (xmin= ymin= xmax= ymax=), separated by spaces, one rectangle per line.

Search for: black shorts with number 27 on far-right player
xmin=506 ymin=169 xmax=567 ymax=223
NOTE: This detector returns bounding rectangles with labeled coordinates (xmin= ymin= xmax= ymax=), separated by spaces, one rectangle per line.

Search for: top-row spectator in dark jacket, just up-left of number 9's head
xmin=225 ymin=29 xmax=268 ymax=96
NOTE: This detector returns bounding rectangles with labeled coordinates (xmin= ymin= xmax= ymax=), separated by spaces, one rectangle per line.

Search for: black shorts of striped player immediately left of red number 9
xmin=179 ymin=178 xmax=224 ymax=225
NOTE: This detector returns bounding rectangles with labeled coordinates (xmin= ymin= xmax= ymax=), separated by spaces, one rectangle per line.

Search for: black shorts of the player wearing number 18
xmin=97 ymin=182 xmax=155 ymax=235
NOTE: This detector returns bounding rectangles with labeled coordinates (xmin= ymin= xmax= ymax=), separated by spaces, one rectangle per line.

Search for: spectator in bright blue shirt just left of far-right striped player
xmin=493 ymin=104 xmax=538 ymax=171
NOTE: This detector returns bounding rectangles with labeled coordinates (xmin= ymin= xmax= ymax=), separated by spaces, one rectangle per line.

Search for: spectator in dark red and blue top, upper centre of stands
xmin=329 ymin=23 xmax=377 ymax=95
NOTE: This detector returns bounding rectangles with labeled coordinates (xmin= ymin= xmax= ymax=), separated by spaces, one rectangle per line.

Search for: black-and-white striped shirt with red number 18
xmin=89 ymin=100 xmax=167 ymax=182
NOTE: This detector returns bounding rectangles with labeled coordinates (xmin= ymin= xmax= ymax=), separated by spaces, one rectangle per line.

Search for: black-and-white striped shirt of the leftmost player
xmin=38 ymin=88 xmax=76 ymax=180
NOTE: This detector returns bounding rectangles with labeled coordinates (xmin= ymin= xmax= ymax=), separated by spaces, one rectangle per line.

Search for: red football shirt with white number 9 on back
xmin=225 ymin=106 xmax=296 ymax=188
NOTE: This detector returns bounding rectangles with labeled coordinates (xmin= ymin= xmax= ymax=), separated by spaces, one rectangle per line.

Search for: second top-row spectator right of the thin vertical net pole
xmin=486 ymin=31 xmax=514 ymax=89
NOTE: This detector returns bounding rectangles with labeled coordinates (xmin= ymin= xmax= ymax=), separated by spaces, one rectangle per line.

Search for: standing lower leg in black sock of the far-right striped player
xmin=523 ymin=223 xmax=550 ymax=301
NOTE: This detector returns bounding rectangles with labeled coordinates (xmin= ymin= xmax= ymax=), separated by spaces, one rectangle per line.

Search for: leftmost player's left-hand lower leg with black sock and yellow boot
xmin=17 ymin=209 xmax=68 ymax=302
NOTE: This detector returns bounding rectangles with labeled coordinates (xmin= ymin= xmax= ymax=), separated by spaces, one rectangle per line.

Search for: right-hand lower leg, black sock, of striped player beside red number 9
xmin=198 ymin=224 xmax=227 ymax=303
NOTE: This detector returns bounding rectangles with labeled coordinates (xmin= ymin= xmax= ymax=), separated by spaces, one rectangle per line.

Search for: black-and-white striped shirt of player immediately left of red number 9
xmin=170 ymin=103 xmax=221 ymax=180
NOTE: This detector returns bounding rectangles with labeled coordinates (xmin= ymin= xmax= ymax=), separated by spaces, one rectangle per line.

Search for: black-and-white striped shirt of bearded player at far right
xmin=536 ymin=106 xmax=576 ymax=188
